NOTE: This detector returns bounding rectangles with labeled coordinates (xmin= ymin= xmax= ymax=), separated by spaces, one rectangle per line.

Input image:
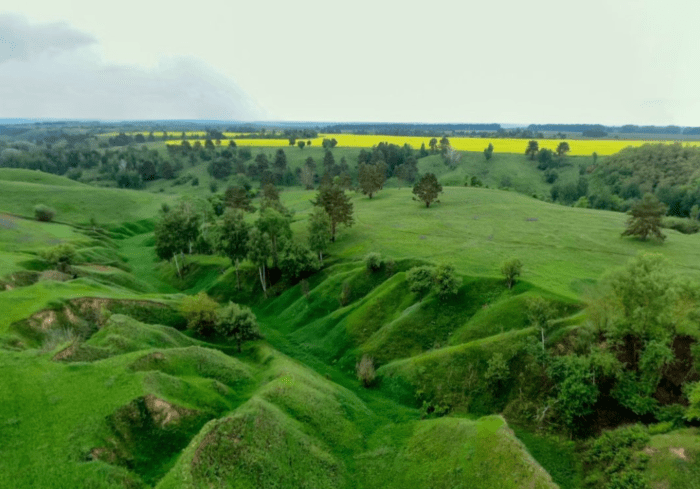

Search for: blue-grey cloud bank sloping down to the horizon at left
xmin=0 ymin=15 xmax=267 ymax=120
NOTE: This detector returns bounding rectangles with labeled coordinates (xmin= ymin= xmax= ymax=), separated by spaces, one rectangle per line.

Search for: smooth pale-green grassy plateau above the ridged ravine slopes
xmin=282 ymin=187 xmax=700 ymax=298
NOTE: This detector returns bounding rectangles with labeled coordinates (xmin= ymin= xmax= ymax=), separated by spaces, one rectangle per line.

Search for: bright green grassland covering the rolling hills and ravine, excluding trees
xmin=0 ymin=143 xmax=700 ymax=489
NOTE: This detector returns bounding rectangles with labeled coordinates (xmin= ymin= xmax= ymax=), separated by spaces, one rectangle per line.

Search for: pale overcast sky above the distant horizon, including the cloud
xmin=0 ymin=0 xmax=700 ymax=126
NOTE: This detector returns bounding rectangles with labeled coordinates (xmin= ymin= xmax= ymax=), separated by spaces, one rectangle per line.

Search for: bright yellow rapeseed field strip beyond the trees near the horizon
xmin=156 ymin=132 xmax=700 ymax=156
